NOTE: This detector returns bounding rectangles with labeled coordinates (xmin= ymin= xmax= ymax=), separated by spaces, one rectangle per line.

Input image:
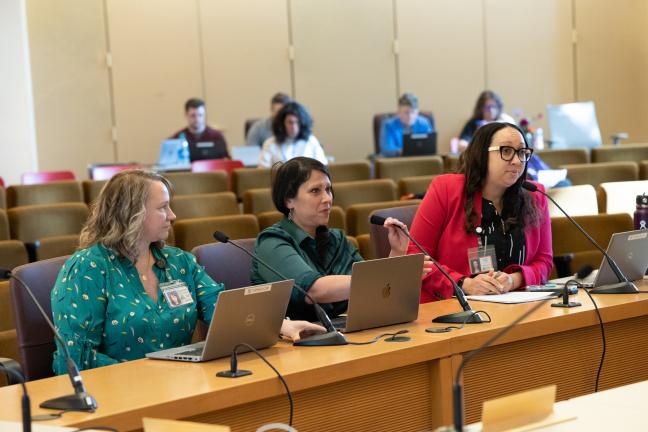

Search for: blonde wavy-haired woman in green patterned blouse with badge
xmin=51 ymin=170 xmax=324 ymax=374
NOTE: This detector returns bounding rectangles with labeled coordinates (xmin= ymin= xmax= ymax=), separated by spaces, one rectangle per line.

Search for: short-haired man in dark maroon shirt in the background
xmin=171 ymin=98 xmax=230 ymax=162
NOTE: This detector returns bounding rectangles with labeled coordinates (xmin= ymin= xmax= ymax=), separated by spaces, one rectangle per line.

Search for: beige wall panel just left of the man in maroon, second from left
xmin=107 ymin=0 xmax=202 ymax=163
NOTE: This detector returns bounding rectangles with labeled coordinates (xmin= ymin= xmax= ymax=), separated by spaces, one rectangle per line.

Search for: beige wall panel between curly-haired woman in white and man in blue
xmin=291 ymin=0 xmax=397 ymax=162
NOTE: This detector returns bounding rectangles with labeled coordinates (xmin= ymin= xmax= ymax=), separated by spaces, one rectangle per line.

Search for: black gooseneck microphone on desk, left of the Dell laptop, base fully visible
xmin=0 ymin=269 xmax=97 ymax=412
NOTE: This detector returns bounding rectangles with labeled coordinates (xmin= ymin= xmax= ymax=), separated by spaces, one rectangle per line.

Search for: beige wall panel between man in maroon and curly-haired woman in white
xmin=199 ymin=0 xmax=292 ymax=146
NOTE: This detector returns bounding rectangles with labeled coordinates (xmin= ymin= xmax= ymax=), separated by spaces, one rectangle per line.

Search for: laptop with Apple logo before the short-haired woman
xmin=333 ymin=254 xmax=424 ymax=332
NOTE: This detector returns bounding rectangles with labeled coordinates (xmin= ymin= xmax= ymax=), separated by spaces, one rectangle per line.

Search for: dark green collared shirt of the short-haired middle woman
xmin=251 ymin=218 xmax=363 ymax=321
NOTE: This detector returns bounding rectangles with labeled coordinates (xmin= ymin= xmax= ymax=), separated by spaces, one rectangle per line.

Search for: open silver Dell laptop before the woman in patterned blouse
xmin=146 ymin=280 xmax=294 ymax=362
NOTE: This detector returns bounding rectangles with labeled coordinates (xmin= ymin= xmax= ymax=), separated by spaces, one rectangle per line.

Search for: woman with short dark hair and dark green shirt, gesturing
xmin=251 ymin=157 xmax=427 ymax=321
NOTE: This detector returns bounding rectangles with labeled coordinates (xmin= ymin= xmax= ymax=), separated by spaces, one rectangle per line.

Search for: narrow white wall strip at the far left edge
xmin=0 ymin=0 xmax=37 ymax=184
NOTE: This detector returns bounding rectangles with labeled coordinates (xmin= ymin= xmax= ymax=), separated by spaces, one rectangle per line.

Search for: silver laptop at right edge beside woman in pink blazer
xmin=550 ymin=230 xmax=648 ymax=288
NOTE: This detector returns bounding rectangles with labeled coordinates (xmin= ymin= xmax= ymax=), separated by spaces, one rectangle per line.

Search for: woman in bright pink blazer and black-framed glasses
xmin=408 ymin=122 xmax=553 ymax=302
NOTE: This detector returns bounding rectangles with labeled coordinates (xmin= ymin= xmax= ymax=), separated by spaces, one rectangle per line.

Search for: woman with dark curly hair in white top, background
xmin=259 ymin=102 xmax=328 ymax=168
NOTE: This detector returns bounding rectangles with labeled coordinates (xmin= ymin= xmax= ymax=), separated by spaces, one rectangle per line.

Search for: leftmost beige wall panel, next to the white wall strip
xmin=27 ymin=0 xmax=115 ymax=178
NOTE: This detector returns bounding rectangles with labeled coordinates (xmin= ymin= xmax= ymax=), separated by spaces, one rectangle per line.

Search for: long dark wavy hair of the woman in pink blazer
xmin=459 ymin=122 xmax=540 ymax=233
